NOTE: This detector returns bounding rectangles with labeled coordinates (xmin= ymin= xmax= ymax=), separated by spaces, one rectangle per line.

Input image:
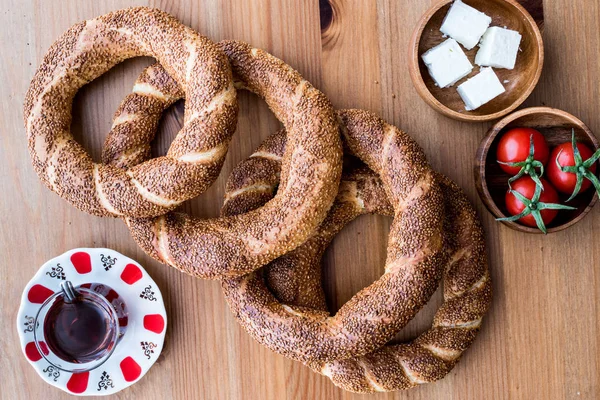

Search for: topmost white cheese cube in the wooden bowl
xmin=440 ymin=0 xmax=492 ymax=50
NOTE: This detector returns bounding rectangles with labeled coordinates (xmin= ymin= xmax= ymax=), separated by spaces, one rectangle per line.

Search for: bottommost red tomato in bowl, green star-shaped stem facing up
xmin=504 ymin=176 xmax=558 ymax=228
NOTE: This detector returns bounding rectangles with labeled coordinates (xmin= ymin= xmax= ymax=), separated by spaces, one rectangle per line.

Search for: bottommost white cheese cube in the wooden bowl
xmin=457 ymin=68 xmax=506 ymax=111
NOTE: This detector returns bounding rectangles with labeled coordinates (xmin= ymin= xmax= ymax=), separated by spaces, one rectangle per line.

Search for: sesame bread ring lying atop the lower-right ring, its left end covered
xmin=222 ymin=110 xmax=445 ymax=362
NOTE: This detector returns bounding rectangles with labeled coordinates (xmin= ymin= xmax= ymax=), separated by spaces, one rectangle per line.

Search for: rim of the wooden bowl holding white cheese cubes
xmin=408 ymin=0 xmax=545 ymax=122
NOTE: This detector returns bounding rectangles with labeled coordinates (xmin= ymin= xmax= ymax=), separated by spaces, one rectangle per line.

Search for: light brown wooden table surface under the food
xmin=0 ymin=0 xmax=600 ymax=400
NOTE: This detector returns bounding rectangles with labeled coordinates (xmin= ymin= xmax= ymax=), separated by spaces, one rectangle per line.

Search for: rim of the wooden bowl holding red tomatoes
xmin=474 ymin=107 xmax=600 ymax=234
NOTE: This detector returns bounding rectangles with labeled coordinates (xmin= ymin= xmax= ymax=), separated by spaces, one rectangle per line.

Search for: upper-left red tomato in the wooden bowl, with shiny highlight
xmin=496 ymin=128 xmax=550 ymax=176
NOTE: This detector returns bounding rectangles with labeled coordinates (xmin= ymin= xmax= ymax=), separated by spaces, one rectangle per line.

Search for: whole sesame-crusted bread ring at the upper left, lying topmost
xmin=24 ymin=7 xmax=237 ymax=217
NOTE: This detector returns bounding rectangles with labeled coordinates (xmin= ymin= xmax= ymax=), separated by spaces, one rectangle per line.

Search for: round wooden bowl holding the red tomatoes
xmin=474 ymin=107 xmax=599 ymax=233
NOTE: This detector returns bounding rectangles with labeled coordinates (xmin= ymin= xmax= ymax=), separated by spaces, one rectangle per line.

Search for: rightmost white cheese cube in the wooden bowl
xmin=475 ymin=26 xmax=521 ymax=69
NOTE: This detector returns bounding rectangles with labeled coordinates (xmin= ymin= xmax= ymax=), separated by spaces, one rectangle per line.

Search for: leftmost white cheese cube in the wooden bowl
xmin=421 ymin=39 xmax=473 ymax=88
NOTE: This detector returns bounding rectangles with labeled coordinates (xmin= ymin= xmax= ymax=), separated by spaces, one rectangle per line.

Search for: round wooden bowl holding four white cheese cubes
xmin=409 ymin=0 xmax=544 ymax=122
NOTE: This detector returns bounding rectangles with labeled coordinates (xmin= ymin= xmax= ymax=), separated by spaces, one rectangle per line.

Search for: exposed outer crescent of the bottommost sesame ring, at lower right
xmin=311 ymin=175 xmax=492 ymax=393
